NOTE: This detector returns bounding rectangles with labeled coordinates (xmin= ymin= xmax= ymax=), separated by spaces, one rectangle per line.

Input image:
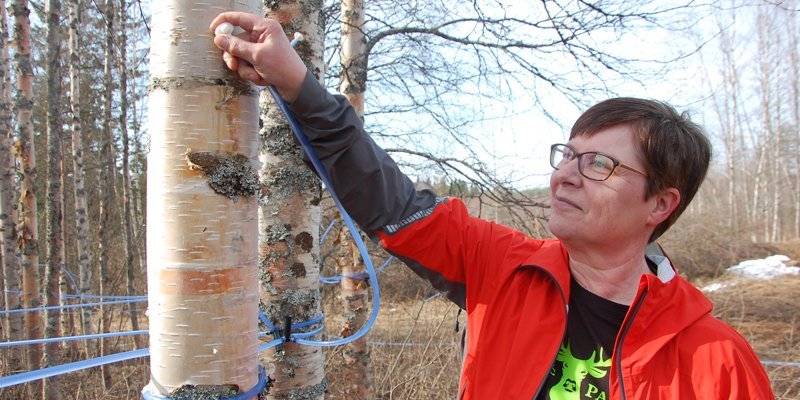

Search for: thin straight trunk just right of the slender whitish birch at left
xmin=98 ymin=0 xmax=116 ymax=390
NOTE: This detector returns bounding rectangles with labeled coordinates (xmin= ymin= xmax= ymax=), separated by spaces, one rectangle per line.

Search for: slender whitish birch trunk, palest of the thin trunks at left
xmin=69 ymin=0 xmax=95 ymax=357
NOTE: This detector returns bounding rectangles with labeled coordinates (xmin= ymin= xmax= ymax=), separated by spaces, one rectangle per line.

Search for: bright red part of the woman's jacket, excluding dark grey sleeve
xmin=379 ymin=199 xmax=774 ymax=400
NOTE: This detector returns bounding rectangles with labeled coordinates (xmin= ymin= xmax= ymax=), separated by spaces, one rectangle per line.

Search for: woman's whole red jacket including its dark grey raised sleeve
xmin=292 ymin=73 xmax=774 ymax=400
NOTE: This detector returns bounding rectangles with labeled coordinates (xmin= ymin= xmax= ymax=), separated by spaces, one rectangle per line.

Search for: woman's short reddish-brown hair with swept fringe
xmin=569 ymin=97 xmax=711 ymax=242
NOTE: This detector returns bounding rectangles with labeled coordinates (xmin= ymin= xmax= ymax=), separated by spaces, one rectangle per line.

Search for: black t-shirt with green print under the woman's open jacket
xmin=537 ymin=279 xmax=628 ymax=400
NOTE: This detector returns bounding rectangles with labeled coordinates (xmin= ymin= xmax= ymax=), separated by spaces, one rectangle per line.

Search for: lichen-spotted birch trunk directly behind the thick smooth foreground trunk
xmin=259 ymin=1 xmax=327 ymax=399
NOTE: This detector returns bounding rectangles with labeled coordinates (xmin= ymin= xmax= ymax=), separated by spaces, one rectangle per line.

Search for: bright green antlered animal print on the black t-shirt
xmin=549 ymin=342 xmax=611 ymax=400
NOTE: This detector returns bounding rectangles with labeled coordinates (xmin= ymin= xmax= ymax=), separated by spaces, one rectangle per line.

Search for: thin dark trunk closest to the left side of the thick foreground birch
xmin=119 ymin=0 xmax=143 ymax=349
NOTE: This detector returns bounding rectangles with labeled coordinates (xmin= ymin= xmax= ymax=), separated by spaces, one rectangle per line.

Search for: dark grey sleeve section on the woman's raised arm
xmin=290 ymin=73 xmax=437 ymax=239
